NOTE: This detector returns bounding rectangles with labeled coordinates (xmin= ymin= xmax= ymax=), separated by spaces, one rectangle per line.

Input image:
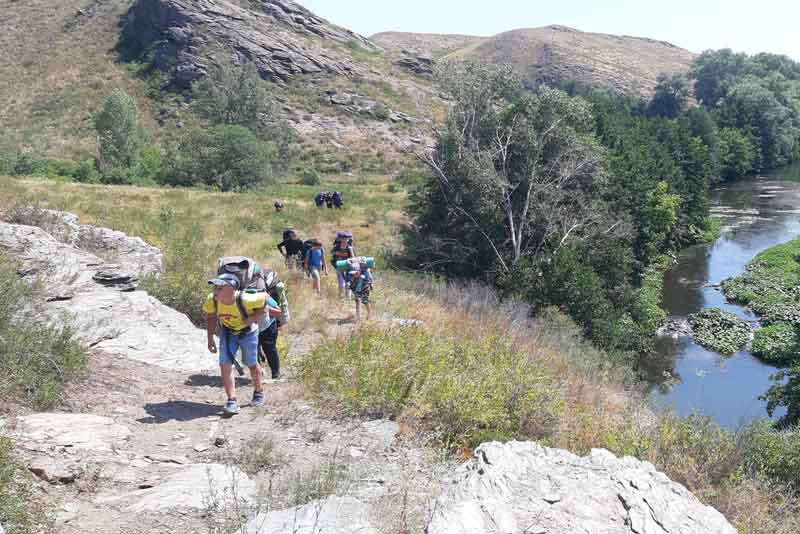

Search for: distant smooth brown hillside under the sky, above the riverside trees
xmin=445 ymin=26 xmax=696 ymax=97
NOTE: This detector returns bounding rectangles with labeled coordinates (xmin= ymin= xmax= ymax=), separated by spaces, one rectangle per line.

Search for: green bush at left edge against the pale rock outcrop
xmin=0 ymin=255 xmax=87 ymax=410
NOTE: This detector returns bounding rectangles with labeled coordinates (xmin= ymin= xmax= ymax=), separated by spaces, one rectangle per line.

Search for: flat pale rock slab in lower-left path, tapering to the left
xmin=98 ymin=464 xmax=257 ymax=513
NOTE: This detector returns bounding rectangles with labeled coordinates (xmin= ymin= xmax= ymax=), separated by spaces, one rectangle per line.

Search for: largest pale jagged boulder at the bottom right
xmin=426 ymin=441 xmax=736 ymax=534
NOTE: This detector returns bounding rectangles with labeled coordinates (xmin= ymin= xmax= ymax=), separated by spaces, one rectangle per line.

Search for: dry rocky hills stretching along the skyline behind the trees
xmin=0 ymin=0 xmax=694 ymax=173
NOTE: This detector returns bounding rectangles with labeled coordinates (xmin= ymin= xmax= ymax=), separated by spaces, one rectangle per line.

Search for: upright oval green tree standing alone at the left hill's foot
xmin=94 ymin=89 xmax=144 ymax=170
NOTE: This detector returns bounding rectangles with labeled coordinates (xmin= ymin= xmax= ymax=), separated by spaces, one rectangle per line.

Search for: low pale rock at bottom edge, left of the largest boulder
xmin=245 ymin=496 xmax=381 ymax=534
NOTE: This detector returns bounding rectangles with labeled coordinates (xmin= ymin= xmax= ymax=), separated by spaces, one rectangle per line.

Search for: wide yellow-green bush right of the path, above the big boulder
xmin=298 ymin=327 xmax=564 ymax=446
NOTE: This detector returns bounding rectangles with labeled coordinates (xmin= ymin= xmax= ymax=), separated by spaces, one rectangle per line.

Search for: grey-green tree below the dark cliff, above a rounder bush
xmin=194 ymin=62 xmax=274 ymax=132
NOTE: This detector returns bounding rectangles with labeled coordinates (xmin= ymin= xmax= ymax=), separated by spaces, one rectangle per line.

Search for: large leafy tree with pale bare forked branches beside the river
xmin=414 ymin=62 xmax=604 ymax=275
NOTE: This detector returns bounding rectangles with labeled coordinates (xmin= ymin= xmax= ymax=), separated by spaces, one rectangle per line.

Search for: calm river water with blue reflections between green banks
xmin=643 ymin=165 xmax=800 ymax=429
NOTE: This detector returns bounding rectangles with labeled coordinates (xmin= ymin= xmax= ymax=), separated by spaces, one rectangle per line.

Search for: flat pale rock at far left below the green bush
xmin=16 ymin=413 xmax=131 ymax=452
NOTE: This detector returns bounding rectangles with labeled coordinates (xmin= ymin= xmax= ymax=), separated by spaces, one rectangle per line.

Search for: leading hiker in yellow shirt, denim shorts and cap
xmin=203 ymin=274 xmax=281 ymax=415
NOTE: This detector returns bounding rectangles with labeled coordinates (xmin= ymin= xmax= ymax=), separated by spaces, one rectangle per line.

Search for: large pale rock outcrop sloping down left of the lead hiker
xmin=0 ymin=218 xmax=216 ymax=371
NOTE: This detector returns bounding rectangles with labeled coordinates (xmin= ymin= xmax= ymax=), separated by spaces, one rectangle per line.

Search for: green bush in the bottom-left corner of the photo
xmin=0 ymin=437 xmax=33 ymax=534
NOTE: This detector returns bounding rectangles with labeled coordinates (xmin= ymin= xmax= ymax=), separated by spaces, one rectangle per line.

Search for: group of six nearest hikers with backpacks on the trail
xmin=203 ymin=228 xmax=375 ymax=415
